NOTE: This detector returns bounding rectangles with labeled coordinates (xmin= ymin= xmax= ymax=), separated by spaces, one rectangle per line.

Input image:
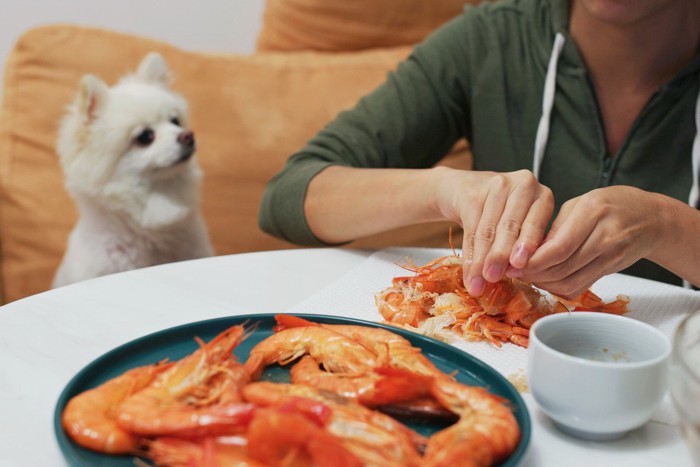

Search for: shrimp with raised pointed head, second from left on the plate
xmin=117 ymin=326 xmax=254 ymax=436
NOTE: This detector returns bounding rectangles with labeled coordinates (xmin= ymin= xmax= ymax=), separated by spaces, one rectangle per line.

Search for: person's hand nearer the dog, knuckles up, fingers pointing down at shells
xmin=438 ymin=170 xmax=554 ymax=297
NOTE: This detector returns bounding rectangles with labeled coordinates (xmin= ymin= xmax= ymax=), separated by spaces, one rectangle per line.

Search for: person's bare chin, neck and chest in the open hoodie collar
xmin=569 ymin=0 xmax=700 ymax=156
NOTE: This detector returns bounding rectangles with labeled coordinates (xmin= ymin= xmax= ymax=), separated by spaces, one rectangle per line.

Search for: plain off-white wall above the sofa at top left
xmin=0 ymin=0 xmax=264 ymax=97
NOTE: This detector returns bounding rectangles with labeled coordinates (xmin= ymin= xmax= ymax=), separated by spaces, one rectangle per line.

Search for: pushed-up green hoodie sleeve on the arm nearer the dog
xmin=259 ymin=7 xmax=486 ymax=246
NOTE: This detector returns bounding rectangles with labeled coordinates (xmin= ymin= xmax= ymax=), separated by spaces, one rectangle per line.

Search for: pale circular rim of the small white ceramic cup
xmin=530 ymin=311 xmax=674 ymax=370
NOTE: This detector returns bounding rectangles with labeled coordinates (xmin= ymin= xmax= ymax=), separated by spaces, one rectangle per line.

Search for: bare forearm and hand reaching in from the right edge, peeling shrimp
xmin=508 ymin=186 xmax=700 ymax=297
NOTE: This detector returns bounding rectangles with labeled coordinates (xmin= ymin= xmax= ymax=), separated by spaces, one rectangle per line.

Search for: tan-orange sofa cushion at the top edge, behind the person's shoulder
xmin=256 ymin=0 xmax=477 ymax=51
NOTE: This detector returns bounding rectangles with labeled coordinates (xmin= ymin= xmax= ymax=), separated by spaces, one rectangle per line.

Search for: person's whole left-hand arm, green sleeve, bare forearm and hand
xmin=260 ymin=3 xmax=553 ymax=295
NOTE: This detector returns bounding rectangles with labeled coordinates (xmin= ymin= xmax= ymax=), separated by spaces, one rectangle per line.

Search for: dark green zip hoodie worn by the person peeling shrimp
xmin=259 ymin=0 xmax=700 ymax=284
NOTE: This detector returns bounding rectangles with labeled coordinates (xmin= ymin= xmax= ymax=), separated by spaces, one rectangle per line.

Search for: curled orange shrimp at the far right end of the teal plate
xmin=423 ymin=381 xmax=520 ymax=467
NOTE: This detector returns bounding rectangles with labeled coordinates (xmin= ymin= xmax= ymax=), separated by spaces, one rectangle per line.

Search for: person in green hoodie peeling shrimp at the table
xmin=260 ymin=0 xmax=700 ymax=297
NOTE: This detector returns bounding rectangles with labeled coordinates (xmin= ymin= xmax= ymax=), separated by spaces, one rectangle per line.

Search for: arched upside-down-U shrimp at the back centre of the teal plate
xmin=245 ymin=326 xmax=379 ymax=380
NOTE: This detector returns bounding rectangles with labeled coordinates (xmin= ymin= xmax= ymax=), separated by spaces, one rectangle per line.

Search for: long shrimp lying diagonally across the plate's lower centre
xmin=243 ymin=382 xmax=425 ymax=467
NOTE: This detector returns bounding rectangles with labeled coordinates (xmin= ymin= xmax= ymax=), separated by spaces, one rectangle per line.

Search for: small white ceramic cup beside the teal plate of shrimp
xmin=527 ymin=311 xmax=671 ymax=441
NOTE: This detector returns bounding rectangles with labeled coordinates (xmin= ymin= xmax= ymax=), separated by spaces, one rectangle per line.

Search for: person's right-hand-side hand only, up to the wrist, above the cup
xmin=508 ymin=186 xmax=668 ymax=298
